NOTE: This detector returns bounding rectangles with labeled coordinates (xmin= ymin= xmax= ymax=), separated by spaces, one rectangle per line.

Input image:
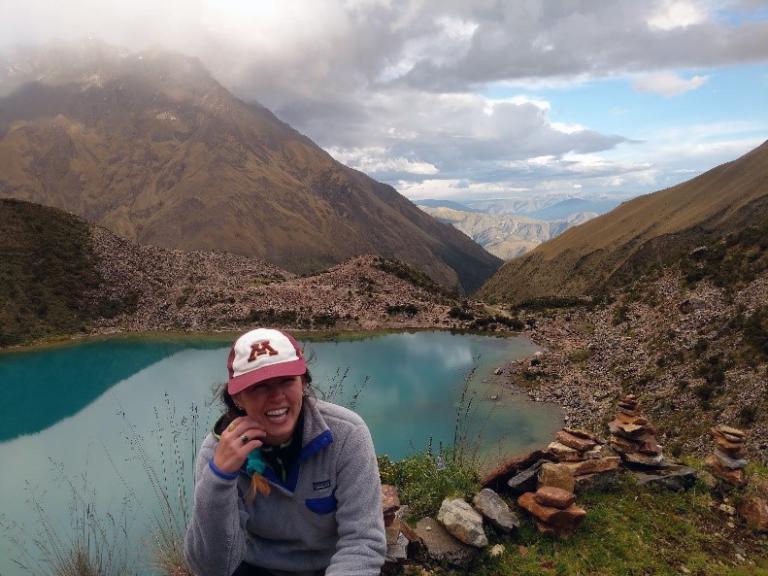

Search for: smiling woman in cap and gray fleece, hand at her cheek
xmin=184 ymin=328 xmax=386 ymax=576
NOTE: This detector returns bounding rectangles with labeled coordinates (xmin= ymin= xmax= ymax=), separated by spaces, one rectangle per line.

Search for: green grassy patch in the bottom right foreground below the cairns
xmin=467 ymin=478 xmax=768 ymax=576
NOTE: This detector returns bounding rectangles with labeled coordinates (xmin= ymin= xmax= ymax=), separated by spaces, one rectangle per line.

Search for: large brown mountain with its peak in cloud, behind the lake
xmin=0 ymin=42 xmax=500 ymax=292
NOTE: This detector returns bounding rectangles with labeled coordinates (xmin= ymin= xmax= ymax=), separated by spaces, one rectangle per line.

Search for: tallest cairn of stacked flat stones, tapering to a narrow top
xmin=608 ymin=394 xmax=666 ymax=468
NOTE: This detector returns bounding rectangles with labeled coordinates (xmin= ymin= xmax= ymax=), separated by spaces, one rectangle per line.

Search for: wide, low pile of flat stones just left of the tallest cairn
xmin=539 ymin=428 xmax=621 ymax=491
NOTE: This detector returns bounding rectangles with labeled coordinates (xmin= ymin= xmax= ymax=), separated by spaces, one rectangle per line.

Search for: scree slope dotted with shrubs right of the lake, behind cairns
xmin=500 ymin=252 xmax=768 ymax=463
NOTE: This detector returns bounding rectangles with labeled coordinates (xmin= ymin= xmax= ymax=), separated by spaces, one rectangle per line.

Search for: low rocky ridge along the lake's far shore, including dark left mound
xmin=0 ymin=200 xmax=510 ymax=347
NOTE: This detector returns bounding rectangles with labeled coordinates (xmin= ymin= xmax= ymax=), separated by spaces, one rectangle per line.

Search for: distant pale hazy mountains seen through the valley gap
xmin=421 ymin=206 xmax=597 ymax=260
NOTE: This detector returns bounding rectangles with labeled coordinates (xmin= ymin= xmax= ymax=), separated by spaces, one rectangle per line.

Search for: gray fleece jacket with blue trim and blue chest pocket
xmin=184 ymin=398 xmax=386 ymax=576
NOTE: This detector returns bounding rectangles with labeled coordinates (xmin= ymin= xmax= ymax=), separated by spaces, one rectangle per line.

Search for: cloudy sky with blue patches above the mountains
xmin=0 ymin=0 xmax=768 ymax=201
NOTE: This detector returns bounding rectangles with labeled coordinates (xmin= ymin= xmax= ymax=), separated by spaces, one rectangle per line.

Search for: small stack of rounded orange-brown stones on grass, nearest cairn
xmin=517 ymin=486 xmax=587 ymax=538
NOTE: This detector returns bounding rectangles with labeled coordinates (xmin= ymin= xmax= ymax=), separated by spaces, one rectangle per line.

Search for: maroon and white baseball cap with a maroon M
xmin=227 ymin=328 xmax=307 ymax=394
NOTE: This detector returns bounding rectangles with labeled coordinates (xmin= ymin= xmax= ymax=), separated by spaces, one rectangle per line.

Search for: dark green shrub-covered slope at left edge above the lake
xmin=0 ymin=200 xmax=138 ymax=347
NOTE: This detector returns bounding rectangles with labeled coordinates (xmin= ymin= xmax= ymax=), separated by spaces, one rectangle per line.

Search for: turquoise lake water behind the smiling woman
xmin=0 ymin=332 xmax=562 ymax=576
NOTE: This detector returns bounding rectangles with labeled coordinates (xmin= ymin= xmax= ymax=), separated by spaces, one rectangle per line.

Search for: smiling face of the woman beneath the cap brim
xmin=234 ymin=376 xmax=304 ymax=446
